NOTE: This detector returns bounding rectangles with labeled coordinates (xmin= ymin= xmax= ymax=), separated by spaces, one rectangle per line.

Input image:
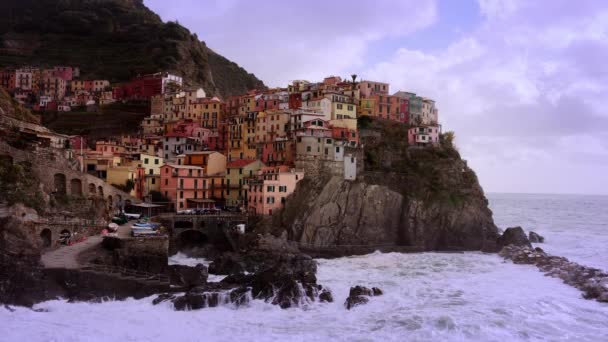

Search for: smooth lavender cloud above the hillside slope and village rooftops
xmin=145 ymin=0 xmax=437 ymax=86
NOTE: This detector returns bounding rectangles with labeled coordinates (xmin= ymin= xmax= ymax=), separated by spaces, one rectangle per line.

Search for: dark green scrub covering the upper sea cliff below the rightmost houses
xmin=359 ymin=118 xmax=480 ymax=208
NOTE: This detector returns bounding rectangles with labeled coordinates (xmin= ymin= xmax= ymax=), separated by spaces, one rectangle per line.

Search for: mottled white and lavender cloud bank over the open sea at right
xmin=365 ymin=0 xmax=608 ymax=193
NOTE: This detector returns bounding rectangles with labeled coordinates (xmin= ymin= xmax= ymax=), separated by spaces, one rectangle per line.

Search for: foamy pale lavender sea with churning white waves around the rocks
xmin=0 ymin=194 xmax=608 ymax=342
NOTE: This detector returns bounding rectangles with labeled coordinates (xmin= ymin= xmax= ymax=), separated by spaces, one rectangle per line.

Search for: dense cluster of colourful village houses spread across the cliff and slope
xmin=0 ymin=67 xmax=441 ymax=215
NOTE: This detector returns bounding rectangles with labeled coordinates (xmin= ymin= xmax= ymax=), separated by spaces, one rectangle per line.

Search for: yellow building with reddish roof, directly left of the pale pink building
xmin=225 ymin=159 xmax=265 ymax=206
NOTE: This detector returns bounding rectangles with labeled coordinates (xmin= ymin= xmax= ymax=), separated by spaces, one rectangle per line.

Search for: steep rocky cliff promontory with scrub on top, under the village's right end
xmin=272 ymin=121 xmax=498 ymax=251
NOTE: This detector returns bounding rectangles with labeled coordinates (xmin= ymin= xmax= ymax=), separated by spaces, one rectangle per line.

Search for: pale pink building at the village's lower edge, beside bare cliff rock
xmin=248 ymin=165 xmax=304 ymax=215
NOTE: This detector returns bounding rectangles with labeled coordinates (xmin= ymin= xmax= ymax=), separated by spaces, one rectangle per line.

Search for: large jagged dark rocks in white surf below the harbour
xmin=153 ymin=251 xmax=332 ymax=310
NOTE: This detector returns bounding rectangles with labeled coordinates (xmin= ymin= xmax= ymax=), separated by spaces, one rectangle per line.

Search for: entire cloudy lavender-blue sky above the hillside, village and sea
xmin=144 ymin=0 xmax=608 ymax=194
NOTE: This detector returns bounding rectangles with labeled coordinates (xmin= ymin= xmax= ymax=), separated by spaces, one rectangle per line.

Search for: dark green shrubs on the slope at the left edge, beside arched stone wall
xmin=0 ymin=158 xmax=44 ymax=212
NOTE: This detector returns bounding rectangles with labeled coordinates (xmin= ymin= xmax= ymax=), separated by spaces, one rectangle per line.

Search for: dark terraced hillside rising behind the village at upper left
xmin=0 ymin=0 xmax=265 ymax=96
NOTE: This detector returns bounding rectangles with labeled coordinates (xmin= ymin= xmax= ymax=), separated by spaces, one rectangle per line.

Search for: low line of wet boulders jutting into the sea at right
xmin=499 ymin=245 xmax=608 ymax=303
